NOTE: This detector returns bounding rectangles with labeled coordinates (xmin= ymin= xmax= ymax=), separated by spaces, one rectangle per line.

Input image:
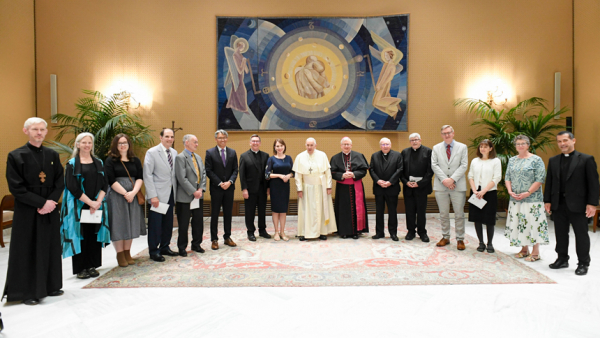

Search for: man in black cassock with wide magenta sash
xmin=330 ymin=137 xmax=369 ymax=239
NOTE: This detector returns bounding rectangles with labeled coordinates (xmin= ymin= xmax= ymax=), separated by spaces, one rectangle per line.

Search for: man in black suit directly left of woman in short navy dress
xmin=240 ymin=134 xmax=271 ymax=242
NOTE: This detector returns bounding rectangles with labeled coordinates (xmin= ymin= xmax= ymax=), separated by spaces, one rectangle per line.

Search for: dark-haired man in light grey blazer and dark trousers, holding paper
xmin=144 ymin=129 xmax=177 ymax=262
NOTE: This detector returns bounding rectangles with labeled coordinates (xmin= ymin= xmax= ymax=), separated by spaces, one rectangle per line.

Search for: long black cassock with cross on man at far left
xmin=4 ymin=143 xmax=64 ymax=302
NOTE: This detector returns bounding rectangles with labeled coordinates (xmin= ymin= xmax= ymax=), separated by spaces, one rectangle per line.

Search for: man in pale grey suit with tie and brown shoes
xmin=431 ymin=125 xmax=469 ymax=250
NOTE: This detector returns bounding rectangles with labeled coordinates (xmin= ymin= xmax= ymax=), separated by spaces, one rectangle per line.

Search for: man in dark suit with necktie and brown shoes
xmin=204 ymin=129 xmax=238 ymax=250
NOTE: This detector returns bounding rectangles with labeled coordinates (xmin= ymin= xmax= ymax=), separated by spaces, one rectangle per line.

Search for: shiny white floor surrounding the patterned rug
xmin=0 ymin=215 xmax=600 ymax=338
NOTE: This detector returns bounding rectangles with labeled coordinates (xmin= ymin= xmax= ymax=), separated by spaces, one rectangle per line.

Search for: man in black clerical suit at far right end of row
xmin=544 ymin=131 xmax=600 ymax=276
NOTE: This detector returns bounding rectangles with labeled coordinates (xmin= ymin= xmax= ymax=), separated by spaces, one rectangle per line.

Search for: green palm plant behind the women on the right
xmin=454 ymin=97 xmax=569 ymax=201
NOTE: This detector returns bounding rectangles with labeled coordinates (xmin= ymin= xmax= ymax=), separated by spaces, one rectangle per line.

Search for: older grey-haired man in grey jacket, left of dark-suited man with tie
xmin=175 ymin=134 xmax=206 ymax=257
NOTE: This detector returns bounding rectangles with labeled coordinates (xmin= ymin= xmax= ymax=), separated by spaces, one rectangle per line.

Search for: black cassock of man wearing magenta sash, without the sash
xmin=330 ymin=151 xmax=369 ymax=236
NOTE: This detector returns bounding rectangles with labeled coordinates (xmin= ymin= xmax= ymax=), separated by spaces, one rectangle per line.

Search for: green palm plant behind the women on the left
xmin=46 ymin=90 xmax=154 ymax=160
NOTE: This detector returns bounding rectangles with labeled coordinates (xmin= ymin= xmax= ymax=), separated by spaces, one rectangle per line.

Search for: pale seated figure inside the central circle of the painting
xmin=294 ymin=55 xmax=329 ymax=99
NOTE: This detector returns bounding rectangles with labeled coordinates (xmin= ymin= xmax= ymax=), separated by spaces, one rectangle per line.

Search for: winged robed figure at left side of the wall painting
xmin=225 ymin=35 xmax=250 ymax=114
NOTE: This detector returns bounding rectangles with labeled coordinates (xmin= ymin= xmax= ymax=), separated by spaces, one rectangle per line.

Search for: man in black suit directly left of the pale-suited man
xmin=400 ymin=133 xmax=433 ymax=242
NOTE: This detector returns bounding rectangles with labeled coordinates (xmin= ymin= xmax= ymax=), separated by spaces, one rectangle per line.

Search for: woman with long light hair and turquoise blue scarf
xmin=60 ymin=133 xmax=110 ymax=279
